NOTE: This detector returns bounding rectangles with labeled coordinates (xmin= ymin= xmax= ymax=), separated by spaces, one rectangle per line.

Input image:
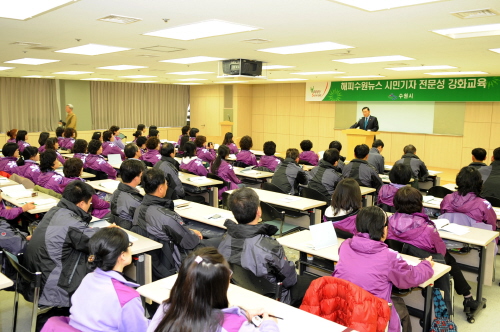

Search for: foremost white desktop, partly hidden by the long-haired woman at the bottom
xmin=137 ymin=275 xmax=347 ymax=332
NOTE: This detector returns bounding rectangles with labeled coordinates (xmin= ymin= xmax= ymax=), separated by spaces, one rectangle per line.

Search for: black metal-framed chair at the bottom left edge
xmin=3 ymin=250 xmax=52 ymax=332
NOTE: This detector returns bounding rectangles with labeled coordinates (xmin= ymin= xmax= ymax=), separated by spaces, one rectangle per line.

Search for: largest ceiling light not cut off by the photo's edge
xmin=144 ymin=20 xmax=261 ymax=40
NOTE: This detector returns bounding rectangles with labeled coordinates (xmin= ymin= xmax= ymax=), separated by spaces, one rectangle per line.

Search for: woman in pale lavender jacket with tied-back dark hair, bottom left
xmin=69 ymin=227 xmax=149 ymax=332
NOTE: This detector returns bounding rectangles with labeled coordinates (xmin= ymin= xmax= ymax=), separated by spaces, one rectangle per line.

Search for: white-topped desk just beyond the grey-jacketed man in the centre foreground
xmin=227 ymin=188 xmax=326 ymax=225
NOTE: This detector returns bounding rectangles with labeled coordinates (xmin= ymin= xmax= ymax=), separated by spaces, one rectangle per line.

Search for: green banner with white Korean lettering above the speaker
xmin=306 ymin=76 xmax=500 ymax=101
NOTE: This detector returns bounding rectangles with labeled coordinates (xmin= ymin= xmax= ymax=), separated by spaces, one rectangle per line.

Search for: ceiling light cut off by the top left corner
xmin=0 ymin=0 xmax=74 ymax=20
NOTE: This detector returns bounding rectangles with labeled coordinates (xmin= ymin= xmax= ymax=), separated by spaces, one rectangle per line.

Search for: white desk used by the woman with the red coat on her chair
xmin=277 ymin=230 xmax=451 ymax=331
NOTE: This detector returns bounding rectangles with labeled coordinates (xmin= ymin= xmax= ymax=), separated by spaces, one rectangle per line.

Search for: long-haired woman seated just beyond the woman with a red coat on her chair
xmin=323 ymin=178 xmax=362 ymax=238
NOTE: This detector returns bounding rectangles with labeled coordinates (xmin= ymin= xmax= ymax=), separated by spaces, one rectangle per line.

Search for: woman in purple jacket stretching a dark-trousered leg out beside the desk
xmin=387 ymin=186 xmax=479 ymax=310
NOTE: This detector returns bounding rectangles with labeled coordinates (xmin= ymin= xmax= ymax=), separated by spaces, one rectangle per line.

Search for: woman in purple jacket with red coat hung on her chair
xmin=332 ymin=206 xmax=434 ymax=332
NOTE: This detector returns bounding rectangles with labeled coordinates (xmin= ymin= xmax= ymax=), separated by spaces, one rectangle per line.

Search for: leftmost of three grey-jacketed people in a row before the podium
xmin=272 ymin=149 xmax=307 ymax=195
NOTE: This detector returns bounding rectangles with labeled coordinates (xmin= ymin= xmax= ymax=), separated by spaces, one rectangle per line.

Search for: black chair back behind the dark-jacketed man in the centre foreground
xmin=229 ymin=263 xmax=283 ymax=301
